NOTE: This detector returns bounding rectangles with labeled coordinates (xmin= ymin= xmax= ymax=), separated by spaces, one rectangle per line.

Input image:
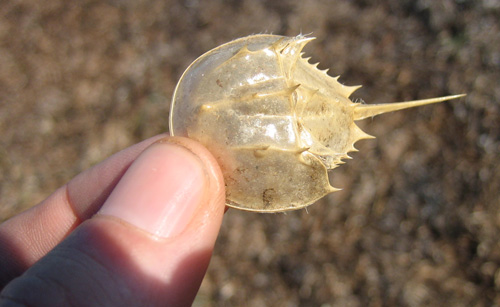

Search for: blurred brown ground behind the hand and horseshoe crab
xmin=0 ymin=0 xmax=500 ymax=306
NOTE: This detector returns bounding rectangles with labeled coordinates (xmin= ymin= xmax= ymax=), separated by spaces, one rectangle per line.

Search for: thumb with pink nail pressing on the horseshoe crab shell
xmin=1 ymin=138 xmax=224 ymax=306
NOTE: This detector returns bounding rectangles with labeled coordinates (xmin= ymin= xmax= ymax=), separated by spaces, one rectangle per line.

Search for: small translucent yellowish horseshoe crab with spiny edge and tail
xmin=170 ymin=35 xmax=464 ymax=212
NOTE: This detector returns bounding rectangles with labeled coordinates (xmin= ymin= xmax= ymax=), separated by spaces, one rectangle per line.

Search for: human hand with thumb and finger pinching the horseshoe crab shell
xmin=0 ymin=135 xmax=225 ymax=306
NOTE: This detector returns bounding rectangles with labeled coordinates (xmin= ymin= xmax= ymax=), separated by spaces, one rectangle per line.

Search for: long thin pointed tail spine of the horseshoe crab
xmin=354 ymin=94 xmax=466 ymax=120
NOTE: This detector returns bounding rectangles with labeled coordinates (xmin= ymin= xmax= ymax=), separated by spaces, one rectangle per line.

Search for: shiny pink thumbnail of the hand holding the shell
xmin=99 ymin=142 xmax=208 ymax=237
